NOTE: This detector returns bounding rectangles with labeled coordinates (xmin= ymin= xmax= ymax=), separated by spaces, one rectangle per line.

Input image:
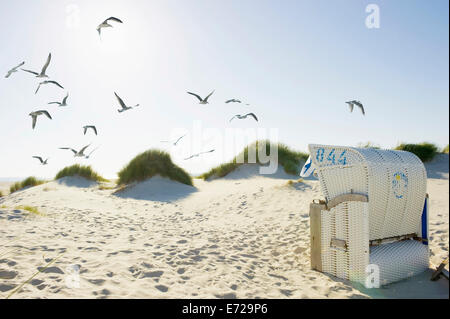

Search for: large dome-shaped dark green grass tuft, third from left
xmin=118 ymin=149 xmax=193 ymax=186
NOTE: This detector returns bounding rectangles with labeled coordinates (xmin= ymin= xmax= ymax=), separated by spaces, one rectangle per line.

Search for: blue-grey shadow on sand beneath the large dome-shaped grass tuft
xmin=114 ymin=176 xmax=198 ymax=203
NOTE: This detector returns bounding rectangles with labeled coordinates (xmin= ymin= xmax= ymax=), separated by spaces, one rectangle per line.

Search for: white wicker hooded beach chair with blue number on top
xmin=309 ymin=145 xmax=429 ymax=286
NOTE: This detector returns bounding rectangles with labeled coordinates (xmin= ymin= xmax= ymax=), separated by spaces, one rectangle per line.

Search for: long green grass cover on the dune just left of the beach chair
xmin=199 ymin=140 xmax=308 ymax=180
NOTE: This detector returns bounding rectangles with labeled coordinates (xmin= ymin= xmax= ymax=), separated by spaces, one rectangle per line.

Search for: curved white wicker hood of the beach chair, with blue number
xmin=309 ymin=145 xmax=426 ymax=240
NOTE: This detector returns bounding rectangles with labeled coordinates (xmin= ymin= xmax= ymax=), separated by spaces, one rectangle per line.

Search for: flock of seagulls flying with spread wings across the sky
xmin=5 ymin=17 xmax=365 ymax=170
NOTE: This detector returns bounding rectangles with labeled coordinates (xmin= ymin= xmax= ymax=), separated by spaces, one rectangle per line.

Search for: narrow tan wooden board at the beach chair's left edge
xmin=309 ymin=202 xmax=327 ymax=271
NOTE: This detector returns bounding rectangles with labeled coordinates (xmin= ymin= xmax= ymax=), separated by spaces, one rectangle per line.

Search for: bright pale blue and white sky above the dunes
xmin=0 ymin=0 xmax=449 ymax=178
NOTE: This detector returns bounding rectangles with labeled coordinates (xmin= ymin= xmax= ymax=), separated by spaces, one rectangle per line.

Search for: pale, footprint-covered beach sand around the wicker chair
xmin=0 ymin=155 xmax=449 ymax=298
